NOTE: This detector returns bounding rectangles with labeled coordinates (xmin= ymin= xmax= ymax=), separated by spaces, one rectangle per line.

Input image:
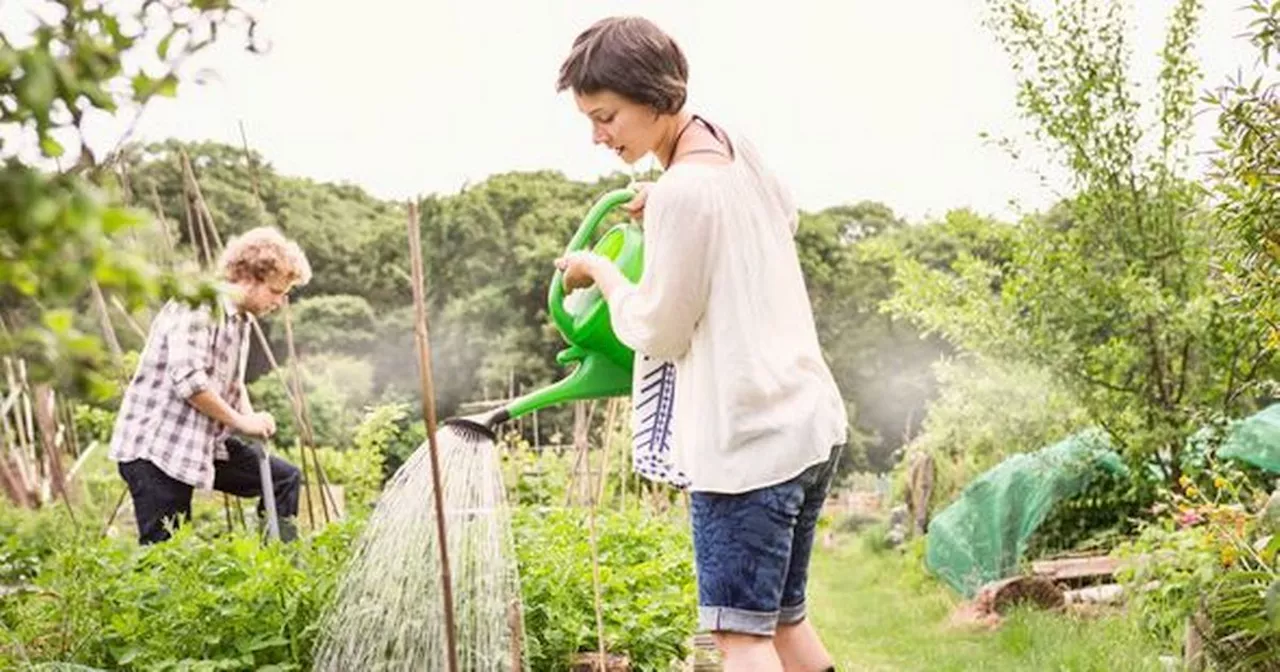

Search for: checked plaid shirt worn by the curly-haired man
xmin=110 ymin=293 xmax=250 ymax=489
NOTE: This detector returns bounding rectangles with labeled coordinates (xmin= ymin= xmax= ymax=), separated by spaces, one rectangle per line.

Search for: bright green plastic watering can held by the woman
xmin=444 ymin=189 xmax=644 ymax=440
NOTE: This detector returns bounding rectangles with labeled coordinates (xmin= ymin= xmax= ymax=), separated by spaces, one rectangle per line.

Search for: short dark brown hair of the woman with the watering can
xmin=556 ymin=17 xmax=689 ymax=114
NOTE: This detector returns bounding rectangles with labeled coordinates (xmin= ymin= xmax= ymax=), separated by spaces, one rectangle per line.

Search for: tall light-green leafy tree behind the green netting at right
xmin=891 ymin=0 xmax=1263 ymax=481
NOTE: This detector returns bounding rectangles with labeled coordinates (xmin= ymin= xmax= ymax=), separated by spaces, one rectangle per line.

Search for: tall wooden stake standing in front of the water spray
xmin=407 ymin=201 xmax=458 ymax=672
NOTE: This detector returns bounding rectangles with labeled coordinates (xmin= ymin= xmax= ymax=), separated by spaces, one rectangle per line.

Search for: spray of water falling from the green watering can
xmin=315 ymin=425 xmax=526 ymax=672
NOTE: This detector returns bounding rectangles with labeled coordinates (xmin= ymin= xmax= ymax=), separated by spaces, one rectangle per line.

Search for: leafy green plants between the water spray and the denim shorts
xmin=515 ymin=507 xmax=696 ymax=672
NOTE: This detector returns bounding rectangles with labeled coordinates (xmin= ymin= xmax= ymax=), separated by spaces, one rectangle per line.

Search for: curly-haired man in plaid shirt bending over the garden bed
xmin=110 ymin=227 xmax=311 ymax=544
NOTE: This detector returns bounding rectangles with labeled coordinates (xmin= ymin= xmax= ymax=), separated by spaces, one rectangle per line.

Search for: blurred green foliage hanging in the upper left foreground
xmin=0 ymin=1 xmax=252 ymax=397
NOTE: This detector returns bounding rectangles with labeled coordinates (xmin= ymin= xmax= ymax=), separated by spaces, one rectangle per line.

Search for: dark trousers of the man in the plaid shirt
xmin=119 ymin=436 xmax=302 ymax=544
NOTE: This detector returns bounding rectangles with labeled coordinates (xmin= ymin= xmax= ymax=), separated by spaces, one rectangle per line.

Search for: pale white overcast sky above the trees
xmin=0 ymin=0 xmax=1253 ymax=220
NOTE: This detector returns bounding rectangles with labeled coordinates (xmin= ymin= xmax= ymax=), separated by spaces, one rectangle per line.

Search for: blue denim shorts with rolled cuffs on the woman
xmin=690 ymin=445 xmax=844 ymax=636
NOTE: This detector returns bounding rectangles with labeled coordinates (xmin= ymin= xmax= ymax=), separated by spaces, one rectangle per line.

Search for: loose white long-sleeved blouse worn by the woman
xmin=609 ymin=128 xmax=849 ymax=493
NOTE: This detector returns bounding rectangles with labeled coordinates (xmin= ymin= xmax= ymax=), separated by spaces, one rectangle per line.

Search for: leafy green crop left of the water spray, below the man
xmin=0 ymin=522 xmax=356 ymax=671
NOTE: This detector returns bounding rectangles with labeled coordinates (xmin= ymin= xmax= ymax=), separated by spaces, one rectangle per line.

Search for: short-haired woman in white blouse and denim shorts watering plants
xmin=557 ymin=18 xmax=847 ymax=672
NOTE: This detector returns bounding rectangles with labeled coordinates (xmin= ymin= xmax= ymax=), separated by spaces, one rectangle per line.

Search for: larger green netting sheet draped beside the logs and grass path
xmin=925 ymin=431 xmax=1124 ymax=598
